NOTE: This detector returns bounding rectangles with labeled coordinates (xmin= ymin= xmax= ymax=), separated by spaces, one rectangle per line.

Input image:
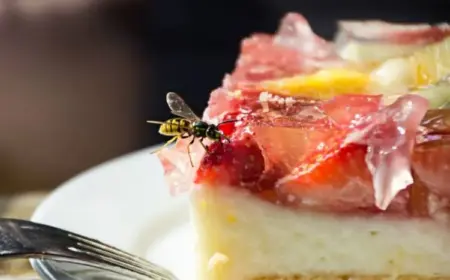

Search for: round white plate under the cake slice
xmin=32 ymin=149 xmax=195 ymax=280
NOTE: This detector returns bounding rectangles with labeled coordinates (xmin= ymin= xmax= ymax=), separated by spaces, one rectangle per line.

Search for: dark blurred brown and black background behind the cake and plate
xmin=0 ymin=0 xmax=449 ymax=193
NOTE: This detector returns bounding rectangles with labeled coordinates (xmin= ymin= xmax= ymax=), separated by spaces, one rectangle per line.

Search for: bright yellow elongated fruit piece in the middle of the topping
xmin=262 ymin=69 xmax=370 ymax=99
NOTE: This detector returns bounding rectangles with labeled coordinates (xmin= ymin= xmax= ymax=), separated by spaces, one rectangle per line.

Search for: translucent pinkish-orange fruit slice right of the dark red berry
xmin=250 ymin=95 xmax=381 ymax=175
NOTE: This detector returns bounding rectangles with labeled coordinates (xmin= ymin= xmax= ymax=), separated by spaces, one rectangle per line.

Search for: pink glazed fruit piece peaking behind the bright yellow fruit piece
xmin=227 ymin=13 xmax=339 ymax=89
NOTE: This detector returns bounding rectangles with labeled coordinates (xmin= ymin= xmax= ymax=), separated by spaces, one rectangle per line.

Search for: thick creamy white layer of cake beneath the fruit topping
xmin=192 ymin=186 xmax=450 ymax=280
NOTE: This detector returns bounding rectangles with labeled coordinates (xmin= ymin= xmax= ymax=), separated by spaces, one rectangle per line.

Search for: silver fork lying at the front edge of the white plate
xmin=0 ymin=219 xmax=177 ymax=280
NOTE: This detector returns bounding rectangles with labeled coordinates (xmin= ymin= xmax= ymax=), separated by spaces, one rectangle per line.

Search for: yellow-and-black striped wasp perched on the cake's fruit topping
xmin=147 ymin=92 xmax=236 ymax=167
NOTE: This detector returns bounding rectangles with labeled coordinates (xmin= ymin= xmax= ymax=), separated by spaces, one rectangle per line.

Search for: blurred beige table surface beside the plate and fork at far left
xmin=0 ymin=192 xmax=47 ymax=280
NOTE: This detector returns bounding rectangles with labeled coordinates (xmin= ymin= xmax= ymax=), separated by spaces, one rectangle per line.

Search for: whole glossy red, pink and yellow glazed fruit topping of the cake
xmin=159 ymin=13 xmax=450 ymax=218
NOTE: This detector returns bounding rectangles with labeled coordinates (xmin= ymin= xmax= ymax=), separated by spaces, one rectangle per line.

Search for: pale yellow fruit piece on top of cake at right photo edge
xmin=408 ymin=38 xmax=450 ymax=86
